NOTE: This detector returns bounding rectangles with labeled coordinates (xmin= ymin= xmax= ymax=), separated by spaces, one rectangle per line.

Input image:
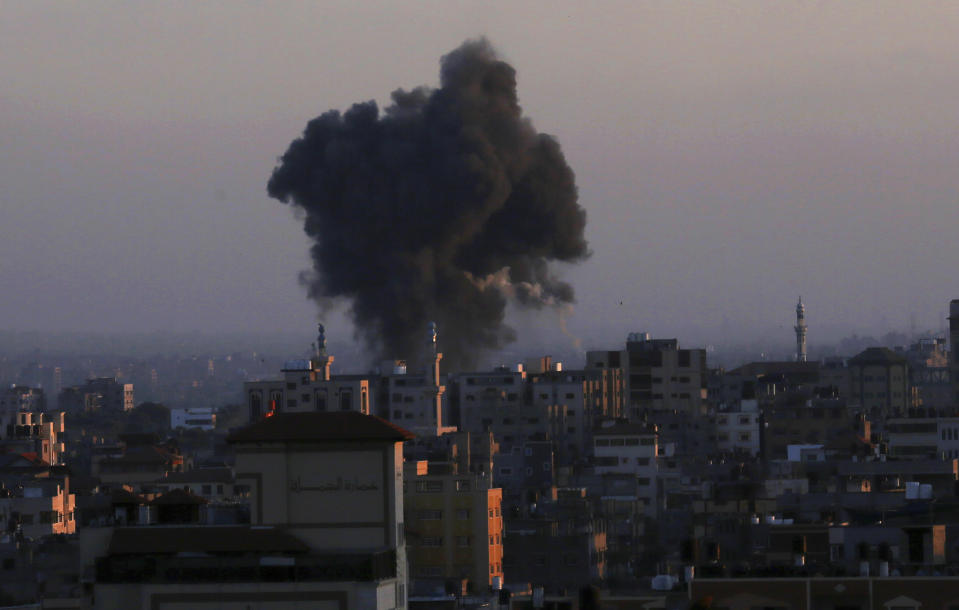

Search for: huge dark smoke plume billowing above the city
xmin=267 ymin=39 xmax=589 ymax=370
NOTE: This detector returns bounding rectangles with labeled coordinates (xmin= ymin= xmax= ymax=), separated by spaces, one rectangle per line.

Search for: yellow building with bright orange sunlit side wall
xmin=404 ymin=461 xmax=503 ymax=593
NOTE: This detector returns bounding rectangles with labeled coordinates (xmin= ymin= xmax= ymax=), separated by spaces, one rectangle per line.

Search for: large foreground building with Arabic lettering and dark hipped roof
xmin=82 ymin=411 xmax=412 ymax=610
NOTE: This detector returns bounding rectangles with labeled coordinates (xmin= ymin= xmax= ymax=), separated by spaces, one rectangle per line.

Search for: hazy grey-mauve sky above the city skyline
xmin=0 ymin=0 xmax=959 ymax=352
